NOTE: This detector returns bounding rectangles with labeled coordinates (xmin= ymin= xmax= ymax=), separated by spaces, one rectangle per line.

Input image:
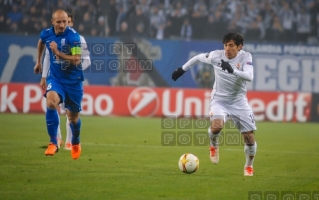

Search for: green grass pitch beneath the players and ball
xmin=0 ymin=114 xmax=319 ymax=199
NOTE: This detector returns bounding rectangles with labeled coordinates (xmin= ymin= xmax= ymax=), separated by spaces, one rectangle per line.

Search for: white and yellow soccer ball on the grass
xmin=178 ymin=153 xmax=199 ymax=174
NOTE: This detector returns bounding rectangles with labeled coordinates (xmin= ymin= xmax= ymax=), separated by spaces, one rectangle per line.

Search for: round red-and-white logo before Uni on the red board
xmin=127 ymin=87 xmax=159 ymax=117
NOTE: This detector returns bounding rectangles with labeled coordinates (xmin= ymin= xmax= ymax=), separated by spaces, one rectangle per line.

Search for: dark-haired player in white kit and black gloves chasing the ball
xmin=172 ymin=33 xmax=257 ymax=176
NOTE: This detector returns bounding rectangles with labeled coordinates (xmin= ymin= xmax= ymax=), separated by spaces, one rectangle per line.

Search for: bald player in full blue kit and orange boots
xmin=34 ymin=9 xmax=84 ymax=159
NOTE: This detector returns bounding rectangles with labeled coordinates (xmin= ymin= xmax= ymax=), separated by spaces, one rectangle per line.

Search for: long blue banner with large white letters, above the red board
xmin=0 ymin=35 xmax=319 ymax=92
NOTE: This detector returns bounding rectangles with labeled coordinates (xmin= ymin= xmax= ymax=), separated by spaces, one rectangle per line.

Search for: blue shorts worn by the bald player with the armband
xmin=44 ymin=79 xmax=83 ymax=112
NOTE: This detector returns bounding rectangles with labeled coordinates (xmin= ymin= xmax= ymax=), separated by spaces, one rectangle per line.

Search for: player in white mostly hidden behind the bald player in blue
xmin=40 ymin=13 xmax=91 ymax=150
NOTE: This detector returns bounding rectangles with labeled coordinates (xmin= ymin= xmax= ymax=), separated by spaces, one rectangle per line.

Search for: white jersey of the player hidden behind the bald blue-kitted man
xmin=42 ymin=35 xmax=91 ymax=77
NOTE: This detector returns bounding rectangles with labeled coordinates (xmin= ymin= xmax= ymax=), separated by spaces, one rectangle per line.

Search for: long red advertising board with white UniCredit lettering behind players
xmin=0 ymin=84 xmax=312 ymax=122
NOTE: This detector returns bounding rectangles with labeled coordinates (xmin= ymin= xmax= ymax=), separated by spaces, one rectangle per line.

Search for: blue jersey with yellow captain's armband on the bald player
xmin=40 ymin=27 xmax=83 ymax=84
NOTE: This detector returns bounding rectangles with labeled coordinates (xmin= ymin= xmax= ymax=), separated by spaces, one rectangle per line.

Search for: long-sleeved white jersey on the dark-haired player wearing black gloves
xmin=182 ymin=50 xmax=254 ymax=103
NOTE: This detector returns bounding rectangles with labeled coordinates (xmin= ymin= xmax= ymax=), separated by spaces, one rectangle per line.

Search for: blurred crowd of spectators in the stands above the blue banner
xmin=0 ymin=0 xmax=319 ymax=44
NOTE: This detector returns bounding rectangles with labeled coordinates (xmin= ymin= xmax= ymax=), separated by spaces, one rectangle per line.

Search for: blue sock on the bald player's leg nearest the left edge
xmin=45 ymin=108 xmax=59 ymax=145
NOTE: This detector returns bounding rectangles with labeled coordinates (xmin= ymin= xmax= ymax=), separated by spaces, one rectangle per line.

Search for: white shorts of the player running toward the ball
xmin=209 ymin=99 xmax=257 ymax=133
